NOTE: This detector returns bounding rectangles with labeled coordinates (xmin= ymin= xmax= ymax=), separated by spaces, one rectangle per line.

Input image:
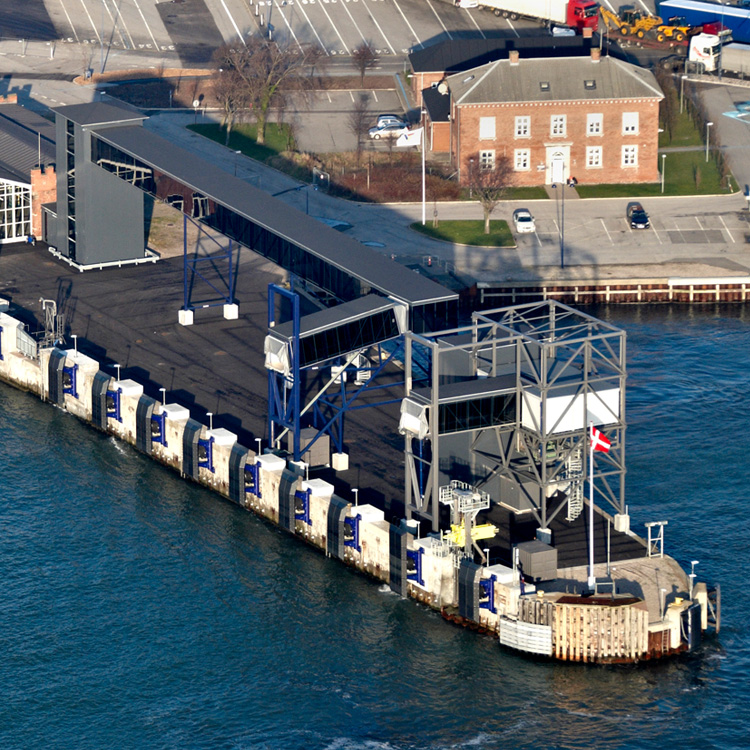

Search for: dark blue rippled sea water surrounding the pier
xmin=0 ymin=307 xmax=750 ymax=750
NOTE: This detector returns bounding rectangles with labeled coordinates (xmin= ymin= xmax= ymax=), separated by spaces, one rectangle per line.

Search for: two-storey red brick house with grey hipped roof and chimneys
xmin=440 ymin=48 xmax=663 ymax=186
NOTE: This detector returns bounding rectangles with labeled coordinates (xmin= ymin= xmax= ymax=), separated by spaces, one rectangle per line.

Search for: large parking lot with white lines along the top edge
xmin=11 ymin=0 xmax=668 ymax=62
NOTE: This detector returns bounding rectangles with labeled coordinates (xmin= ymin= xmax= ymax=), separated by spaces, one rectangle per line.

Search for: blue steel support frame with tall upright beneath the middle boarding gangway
xmin=268 ymin=284 xmax=404 ymax=461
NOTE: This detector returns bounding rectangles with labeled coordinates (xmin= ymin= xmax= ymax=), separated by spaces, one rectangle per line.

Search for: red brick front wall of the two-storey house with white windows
xmin=451 ymin=99 xmax=659 ymax=185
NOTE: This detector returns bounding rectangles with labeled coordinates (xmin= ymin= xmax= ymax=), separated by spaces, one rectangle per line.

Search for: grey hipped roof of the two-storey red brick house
xmin=446 ymin=57 xmax=664 ymax=104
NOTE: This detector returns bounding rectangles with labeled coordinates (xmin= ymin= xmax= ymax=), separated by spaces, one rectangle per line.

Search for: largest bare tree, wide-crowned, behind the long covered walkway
xmin=214 ymin=36 xmax=319 ymax=144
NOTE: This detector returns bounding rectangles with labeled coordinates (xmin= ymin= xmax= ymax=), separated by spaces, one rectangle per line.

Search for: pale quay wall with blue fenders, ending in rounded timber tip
xmin=0 ymin=312 xmax=689 ymax=662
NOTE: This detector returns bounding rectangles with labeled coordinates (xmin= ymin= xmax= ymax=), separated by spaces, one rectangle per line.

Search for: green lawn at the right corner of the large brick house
xmin=576 ymin=151 xmax=737 ymax=198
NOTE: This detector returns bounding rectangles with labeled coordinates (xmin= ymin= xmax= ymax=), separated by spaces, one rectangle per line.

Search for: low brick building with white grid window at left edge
xmin=0 ymin=94 xmax=57 ymax=244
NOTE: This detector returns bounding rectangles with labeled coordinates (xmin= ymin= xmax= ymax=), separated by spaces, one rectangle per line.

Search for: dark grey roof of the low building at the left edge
xmin=0 ymin=104 xmax=55 ymax=183
